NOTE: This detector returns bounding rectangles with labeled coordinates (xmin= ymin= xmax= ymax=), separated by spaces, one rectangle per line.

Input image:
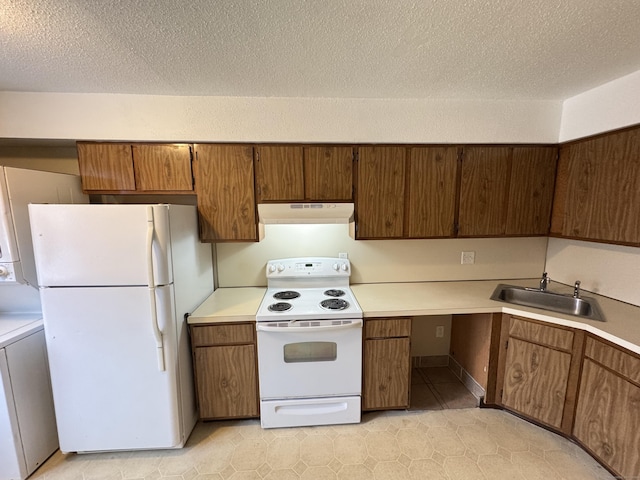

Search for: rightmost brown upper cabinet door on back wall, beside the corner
xmin=505 ymin=147 xmax=558 ymax=235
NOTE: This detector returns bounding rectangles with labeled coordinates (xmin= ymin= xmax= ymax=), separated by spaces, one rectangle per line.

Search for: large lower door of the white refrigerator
xmin=41 ymin=287 xmax=184 ymax=452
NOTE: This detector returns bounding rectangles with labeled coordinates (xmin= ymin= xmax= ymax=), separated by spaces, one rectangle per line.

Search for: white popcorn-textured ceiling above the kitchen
xmin=0 ymin=0 xmax=640 ymax=100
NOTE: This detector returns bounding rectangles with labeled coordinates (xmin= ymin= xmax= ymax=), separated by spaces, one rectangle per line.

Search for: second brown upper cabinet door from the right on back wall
xmin=458 ymin=147 xmax=511 ymax=237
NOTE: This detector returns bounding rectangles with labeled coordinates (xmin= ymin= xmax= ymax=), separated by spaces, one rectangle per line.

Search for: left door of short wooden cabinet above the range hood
xmin=256 ymin=145 xmax=304 ymax=202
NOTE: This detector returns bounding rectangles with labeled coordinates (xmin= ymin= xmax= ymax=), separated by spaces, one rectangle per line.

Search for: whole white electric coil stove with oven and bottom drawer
xmin=256 ymin=257 xmax=362 ymax=428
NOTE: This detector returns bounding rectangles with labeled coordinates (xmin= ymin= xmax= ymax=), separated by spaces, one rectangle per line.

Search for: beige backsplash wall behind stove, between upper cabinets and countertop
xmin=217 ymin=225 xmax=547 ymax=287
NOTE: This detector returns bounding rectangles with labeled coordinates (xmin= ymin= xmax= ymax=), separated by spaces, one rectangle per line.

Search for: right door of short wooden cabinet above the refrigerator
xmin=132 ymin=144 xmax=193 ymax=192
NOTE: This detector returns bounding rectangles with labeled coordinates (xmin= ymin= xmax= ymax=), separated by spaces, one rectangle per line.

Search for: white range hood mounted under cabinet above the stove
xmin=258 ymin=203 xmax=353 ymax=225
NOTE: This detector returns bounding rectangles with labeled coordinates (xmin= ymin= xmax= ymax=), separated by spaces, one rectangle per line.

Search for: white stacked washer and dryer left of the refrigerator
xmin=0 ymin=167 xmax=88 ymax=480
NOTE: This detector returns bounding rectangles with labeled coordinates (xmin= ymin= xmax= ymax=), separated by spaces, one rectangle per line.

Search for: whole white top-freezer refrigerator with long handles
xmin=29 ymin=204 xmax=213 ymax=452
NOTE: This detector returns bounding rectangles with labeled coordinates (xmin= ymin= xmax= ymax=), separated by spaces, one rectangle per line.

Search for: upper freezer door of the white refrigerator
xmin=29 ymin=205 xmax=173 ymax=287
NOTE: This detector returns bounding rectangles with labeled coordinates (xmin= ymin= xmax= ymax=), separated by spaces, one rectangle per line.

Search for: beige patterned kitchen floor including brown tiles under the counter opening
xmin=31 ymin=367 xmax=614 ymax=480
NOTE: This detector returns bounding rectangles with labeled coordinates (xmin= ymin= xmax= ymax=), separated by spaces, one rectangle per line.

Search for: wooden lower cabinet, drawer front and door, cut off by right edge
xmin=573 ymin=337 xmax=640 ymax=479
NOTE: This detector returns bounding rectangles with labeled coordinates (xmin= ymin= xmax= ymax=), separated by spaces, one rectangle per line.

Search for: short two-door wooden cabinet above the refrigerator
xmin=77 ymin=142 xmax=193 ymax=193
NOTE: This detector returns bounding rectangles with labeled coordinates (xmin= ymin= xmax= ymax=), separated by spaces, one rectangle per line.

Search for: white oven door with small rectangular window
xmin=256 ymin=319 xmax=362 ymax=400
